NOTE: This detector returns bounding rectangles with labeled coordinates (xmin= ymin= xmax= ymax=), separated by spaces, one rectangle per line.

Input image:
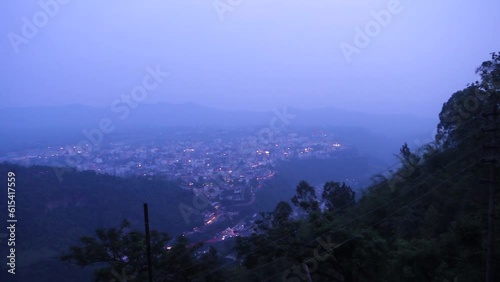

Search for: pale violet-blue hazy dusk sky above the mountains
xmin=0 ymin=0 xmax=500 ymax=117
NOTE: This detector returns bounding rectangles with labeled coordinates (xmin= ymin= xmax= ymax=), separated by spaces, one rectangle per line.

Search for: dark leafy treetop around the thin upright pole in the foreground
xmin=61 ymin=220 xmax=220 ymax=282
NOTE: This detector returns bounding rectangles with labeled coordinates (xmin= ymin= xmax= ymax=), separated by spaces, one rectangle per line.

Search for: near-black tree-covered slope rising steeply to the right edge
xmin=230 ymin=54 xmax=500 ymax=282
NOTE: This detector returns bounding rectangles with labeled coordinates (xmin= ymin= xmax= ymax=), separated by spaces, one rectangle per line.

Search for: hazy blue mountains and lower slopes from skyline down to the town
xmin=0 ymin=103 xmax=438 ymax=161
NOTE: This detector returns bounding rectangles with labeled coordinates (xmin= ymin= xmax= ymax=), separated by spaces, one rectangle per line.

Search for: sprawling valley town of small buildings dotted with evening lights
xmin=0 ymin=133 xmax=346 ymax=206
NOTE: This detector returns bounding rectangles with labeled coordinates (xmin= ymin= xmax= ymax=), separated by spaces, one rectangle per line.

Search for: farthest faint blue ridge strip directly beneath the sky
xmin=0 ymin=102 xmax=437 ymax=133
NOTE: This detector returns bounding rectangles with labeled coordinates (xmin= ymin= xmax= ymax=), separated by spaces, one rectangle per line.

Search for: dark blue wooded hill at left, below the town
xmin=0 ymin=163 xmax=201 ymax=281
